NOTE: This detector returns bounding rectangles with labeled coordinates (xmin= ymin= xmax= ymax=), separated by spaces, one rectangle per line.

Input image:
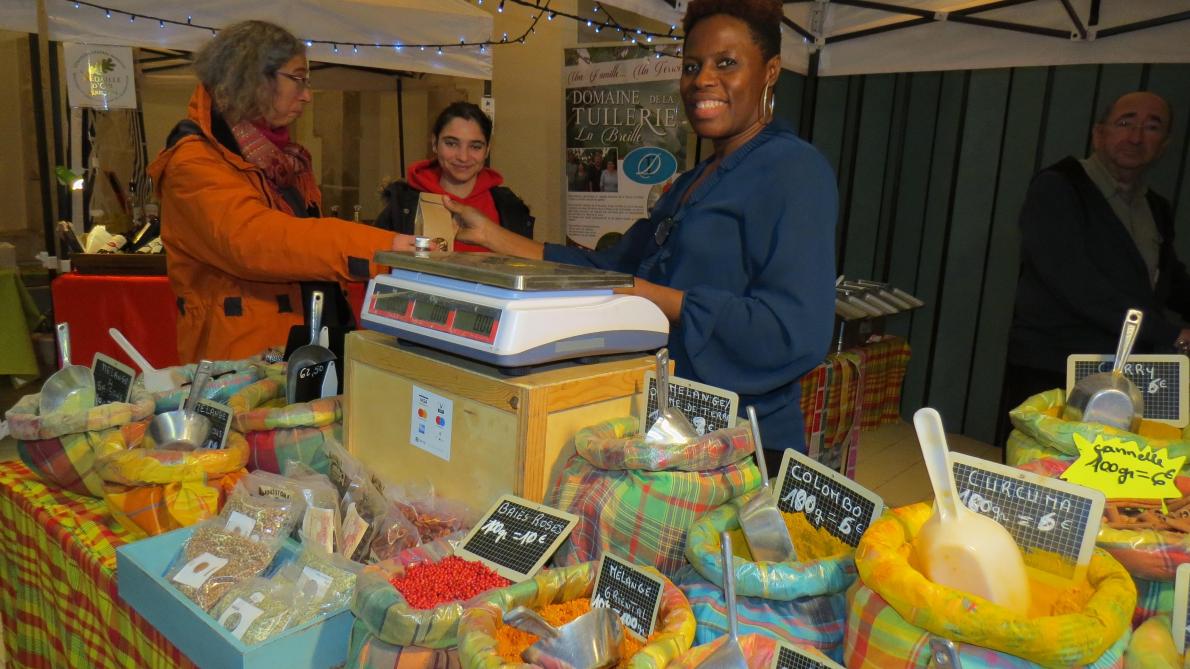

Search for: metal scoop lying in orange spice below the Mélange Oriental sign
xmin=503 ymin=606 xmax=624 ymax=669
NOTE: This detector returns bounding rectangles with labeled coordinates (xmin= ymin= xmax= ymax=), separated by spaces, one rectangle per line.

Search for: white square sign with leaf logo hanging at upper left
xmin=63 ymin=44 xmax=137 ymax=111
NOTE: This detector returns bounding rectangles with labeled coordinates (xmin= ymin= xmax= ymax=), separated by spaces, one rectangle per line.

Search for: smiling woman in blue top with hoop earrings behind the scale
xmin=447 ymin=0 xmax=838 ymax=475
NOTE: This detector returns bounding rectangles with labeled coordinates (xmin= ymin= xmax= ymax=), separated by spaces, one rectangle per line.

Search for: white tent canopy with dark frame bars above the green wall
xmin=601 ymin=0 xmax=1190 ymax=76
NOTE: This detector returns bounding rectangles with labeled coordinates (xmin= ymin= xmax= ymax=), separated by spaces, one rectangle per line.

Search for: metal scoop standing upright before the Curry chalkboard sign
xmin=1061 ymin=310 xmax=1145 ymax=432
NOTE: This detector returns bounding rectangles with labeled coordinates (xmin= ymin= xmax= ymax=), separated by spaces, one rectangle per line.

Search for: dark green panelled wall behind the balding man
xmin=778 ymin=58 xmax=1190 ymax=443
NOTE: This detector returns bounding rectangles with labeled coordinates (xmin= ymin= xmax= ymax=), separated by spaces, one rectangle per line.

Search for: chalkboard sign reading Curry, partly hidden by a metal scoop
xmin=1066 ymin=354 xmax=1190 ymax=427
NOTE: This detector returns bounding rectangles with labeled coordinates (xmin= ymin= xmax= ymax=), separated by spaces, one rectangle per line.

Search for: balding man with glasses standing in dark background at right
xmin=997 ymin=92 xmax=1190 ymax=443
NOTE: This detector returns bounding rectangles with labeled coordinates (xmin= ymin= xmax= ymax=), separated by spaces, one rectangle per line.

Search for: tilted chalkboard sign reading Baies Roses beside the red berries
xmin=456 ymin=495 xmax=578 ymax=583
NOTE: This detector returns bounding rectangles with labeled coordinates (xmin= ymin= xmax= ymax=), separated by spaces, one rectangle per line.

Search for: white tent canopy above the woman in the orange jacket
xmin=0 ymin=0 xmax=491 ymax=79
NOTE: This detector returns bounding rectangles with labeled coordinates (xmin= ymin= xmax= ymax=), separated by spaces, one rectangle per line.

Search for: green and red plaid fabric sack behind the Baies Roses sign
xmin=545 ymin=419 xmax=760 ymax=576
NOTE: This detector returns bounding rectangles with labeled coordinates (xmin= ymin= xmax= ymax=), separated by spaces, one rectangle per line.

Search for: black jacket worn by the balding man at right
xmin=1008 ymin=157 xmax=1190 ymax=371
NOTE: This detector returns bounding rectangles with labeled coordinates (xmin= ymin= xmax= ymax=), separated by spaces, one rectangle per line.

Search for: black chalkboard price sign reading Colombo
xmin=777 ymin=449 xmax=884 ymax=546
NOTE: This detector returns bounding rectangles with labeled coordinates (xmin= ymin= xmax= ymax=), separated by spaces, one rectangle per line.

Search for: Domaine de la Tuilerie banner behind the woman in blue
xmin=564 ymin=45 xmax=690 ymax=249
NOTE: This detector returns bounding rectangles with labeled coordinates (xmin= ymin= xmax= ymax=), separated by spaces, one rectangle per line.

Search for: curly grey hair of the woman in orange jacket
xmin=194 ymin=20 xmax=306 ymax=125
